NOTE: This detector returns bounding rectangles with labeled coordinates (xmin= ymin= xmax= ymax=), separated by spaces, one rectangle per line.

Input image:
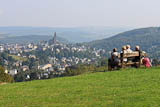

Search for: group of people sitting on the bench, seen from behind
xmin=109 ymin=45 xmax=151 ymax=67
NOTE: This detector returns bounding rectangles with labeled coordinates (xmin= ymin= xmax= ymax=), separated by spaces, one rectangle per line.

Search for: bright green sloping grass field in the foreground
xmin=0 ymin=68 xmax=160 ymax=107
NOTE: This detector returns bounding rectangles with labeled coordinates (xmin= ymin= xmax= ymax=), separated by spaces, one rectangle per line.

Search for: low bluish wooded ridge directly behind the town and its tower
xmin=0 ymin=35 xmax=69 ymax=44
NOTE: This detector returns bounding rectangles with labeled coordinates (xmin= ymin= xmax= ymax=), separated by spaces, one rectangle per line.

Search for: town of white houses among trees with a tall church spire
xmin=0 ymin=33 xmax=106 ymax=81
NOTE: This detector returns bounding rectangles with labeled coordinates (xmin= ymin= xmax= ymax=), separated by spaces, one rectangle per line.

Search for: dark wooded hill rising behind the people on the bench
xmin=88 ymin=27 xmax=160 ymax=54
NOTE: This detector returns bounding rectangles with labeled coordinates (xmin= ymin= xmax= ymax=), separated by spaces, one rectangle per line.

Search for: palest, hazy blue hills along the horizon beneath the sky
xmin=0 ymin=26 xmax=129 ymax=42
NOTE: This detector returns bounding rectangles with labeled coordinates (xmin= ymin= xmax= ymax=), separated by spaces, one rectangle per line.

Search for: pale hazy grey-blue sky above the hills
xmin=0 ymin=0 xmax=160 ymax=28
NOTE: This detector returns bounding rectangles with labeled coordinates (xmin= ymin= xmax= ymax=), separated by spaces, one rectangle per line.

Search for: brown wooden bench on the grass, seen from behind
xmin=108 ymin=51 xmax=145 ymax=70
